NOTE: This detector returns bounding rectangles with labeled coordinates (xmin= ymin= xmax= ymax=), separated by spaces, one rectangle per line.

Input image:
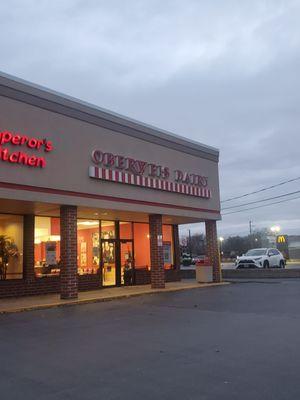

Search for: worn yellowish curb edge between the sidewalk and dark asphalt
xmin=0 ymin=282 xmax=230 ymax=315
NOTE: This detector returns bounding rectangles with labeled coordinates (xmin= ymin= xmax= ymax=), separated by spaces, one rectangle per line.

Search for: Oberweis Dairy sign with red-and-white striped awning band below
xmin=89 ymin=150 xmax=211 ymax=199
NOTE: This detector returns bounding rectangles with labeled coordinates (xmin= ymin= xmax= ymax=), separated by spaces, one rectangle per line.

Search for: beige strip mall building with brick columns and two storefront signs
xmin=0 ymin=74 xmax=221 ymax=298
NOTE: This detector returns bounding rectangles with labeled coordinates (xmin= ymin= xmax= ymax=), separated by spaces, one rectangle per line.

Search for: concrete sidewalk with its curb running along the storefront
xmin=0 ymin=280 xmax=228 ymax=314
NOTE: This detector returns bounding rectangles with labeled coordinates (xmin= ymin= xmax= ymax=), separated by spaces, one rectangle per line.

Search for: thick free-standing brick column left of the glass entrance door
xmin=60 ymin=206 xmax=78 ymax=299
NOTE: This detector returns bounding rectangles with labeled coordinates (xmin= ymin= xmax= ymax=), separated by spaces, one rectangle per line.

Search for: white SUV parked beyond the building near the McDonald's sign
xmin=235 ymin=248 xmax=285 ymax=269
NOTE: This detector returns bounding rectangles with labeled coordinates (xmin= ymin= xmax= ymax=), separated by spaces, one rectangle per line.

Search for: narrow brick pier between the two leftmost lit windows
xmin=23 ymin=214 xmax=35 ymax=282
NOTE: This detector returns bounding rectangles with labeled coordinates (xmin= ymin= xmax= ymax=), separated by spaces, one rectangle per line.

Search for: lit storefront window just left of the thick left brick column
xmin=34 ymin=217 xmax=60 ymax=277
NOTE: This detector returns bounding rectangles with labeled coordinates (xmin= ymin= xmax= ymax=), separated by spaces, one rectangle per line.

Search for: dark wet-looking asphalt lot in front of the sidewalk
xmin=0 ymin=279 xmax=300 ymax=400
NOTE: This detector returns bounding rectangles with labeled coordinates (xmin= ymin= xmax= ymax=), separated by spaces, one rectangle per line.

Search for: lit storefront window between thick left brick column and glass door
xmin=77 ymin=219 xmax=100 ymax=275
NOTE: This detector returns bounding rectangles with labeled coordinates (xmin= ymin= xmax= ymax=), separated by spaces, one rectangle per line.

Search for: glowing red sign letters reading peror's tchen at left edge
xmin=0 ymin=131 xmax=53 ymax=168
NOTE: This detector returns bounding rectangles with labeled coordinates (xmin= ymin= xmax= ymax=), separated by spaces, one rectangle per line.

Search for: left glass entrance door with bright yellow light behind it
xmin=101 ymin=240 xmax=117 ymax=286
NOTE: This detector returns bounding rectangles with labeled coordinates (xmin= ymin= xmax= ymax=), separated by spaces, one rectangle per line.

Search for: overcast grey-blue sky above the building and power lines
xmin=0 ymin=0 xmax=300 ymax=235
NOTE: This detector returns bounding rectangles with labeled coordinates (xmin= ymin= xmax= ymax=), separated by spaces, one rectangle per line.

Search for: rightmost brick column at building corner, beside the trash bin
xmin=205 ymin=220 xmax=222 ymax=282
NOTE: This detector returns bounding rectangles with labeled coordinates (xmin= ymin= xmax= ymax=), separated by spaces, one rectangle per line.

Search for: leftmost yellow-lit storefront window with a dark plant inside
xmin=0 ymin=214 xmax=23 ymax=280
